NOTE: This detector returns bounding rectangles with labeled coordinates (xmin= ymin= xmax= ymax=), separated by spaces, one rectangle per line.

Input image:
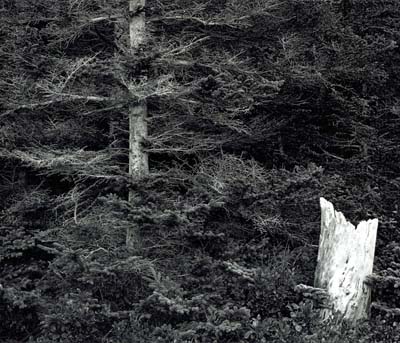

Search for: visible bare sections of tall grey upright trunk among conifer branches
xmin=126 ymin=0 xmax=149 ymax=249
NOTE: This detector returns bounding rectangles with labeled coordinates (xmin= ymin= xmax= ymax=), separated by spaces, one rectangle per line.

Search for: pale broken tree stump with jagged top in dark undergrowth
xmin=314 ymin=198 xmax=378 ymax=324
